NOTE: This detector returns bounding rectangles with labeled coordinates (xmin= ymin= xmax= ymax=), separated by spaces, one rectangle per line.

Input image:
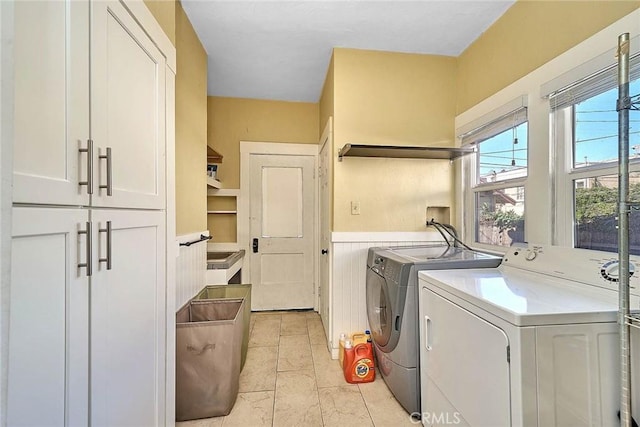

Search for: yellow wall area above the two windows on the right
xmin=457 ymin=0 xmax=640 ymax=113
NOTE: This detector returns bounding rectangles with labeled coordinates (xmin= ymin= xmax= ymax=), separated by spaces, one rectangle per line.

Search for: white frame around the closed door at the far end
xmin=237 ymin=141 xmax=320 ymax=310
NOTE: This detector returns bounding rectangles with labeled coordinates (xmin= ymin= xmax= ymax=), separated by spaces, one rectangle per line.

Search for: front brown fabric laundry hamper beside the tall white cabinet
xmin=176 ymin=299 xmax=245 ymax=421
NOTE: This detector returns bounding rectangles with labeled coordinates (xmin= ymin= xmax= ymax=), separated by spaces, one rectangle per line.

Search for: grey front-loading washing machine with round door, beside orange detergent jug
xmin=366 ymin=244 xmax=501 ymax=415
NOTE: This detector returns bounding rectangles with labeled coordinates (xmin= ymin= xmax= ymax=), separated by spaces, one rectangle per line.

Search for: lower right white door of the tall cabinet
xmin=91 ymin=210 xmax=166 ymax=426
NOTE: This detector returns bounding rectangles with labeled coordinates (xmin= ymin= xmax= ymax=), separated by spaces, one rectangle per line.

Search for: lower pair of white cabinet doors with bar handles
xmin=7 ymin=207 xmax=166 ymax=426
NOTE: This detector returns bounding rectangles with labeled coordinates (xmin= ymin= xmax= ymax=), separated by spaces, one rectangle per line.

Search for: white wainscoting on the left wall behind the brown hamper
xmin=175 ymin=231 xmax=209 ymax=311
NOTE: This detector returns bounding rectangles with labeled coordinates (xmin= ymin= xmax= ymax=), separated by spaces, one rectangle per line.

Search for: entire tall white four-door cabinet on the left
xmin=6 ymin=0 xmax=175 ymax=426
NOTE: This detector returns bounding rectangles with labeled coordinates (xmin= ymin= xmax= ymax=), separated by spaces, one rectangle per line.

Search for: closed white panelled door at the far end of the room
xmin=250 ymin=155 xmax=315 ymax=310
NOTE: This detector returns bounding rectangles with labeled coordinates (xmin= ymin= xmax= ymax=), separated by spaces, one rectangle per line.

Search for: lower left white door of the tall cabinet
xmin=7 ymin=208 xmax=89 ymax=426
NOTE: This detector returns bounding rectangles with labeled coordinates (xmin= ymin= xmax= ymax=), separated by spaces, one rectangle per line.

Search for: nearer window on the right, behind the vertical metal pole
xmin=551 ymin=67 xmax=640 ymax=255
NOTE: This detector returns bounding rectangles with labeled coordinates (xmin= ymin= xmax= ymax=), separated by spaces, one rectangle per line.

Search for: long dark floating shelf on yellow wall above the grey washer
xmin=338 ymin=144 xmax=475 ymax=161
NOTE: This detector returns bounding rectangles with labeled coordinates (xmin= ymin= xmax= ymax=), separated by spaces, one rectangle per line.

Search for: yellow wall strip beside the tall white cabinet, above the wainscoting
xmin=176 ymin=3 xmax=207 ymax=235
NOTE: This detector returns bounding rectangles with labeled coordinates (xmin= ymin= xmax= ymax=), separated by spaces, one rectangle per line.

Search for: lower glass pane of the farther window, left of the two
xmin=476 ymin=187 xmax=524 ymax=246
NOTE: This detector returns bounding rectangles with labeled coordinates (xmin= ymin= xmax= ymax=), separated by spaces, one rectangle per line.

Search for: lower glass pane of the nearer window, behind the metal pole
xmin=574 ymin=172 xmax=640 ymax=255
